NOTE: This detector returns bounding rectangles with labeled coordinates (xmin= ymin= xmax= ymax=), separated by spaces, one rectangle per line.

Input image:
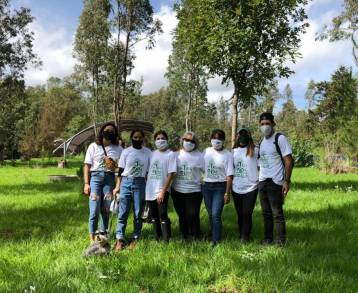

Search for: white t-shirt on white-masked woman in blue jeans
xmin=203 ymin=147 xmax=234 ymax=182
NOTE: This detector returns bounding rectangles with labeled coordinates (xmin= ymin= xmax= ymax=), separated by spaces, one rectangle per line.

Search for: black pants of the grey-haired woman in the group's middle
xmin=171 ymin=188 xmax=203 ymax=239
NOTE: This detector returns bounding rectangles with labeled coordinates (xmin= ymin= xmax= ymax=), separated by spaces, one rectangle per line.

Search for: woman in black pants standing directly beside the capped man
xmin=232 ymin=127 xmax=259 ymax=243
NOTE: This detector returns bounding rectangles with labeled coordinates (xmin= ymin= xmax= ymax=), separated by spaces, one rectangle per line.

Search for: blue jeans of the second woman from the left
xmin=116 ymin=177 xmax=145 ymax=240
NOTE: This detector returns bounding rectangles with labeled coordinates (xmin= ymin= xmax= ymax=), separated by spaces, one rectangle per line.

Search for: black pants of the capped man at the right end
xmin=259 ymin=178 xmax=286 ymax=243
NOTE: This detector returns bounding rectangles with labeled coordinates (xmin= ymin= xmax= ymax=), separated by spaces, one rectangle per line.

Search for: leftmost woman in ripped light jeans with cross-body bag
xmin=83 ymin=123 xmax=123 ymax=242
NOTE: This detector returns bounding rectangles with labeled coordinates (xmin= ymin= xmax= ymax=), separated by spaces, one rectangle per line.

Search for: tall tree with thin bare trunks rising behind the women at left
xmin=107 ymin=0 xmax=162 ymax=125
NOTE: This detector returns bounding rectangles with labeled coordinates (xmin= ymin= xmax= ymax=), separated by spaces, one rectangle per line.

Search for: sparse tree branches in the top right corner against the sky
xmin=316 ymin=0 xmax=358 ymax=66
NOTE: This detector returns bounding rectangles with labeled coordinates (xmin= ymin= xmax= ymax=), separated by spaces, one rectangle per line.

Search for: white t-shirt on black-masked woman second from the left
xmin=119 ymin=146 xmax=152 ymax=177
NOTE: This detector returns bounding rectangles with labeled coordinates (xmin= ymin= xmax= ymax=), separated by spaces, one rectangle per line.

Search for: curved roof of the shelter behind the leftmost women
xmin=53 ymin=119 xmax=154 ymax=153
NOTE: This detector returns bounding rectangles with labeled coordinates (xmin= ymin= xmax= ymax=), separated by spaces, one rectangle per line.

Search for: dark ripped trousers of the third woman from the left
xmin=147 ymin=192 xmax=171 ymax=240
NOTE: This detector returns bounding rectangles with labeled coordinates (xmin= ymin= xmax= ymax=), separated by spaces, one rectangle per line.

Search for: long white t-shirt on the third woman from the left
xmin=145 ymin=150 xmax=177 ymax=200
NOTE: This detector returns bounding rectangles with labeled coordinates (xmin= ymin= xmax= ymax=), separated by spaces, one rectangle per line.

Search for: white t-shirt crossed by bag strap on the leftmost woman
xmin=85 ymin=142 xmax=123 ymax=172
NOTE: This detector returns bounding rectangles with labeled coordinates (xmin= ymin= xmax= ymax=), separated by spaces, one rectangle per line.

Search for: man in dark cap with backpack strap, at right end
xmin=258 ymin=112 xmax=293 ymax=246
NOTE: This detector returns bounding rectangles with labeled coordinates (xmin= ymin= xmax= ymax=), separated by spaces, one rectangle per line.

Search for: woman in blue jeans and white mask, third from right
xmin=202 ymin=129 xmax=234 ymax=246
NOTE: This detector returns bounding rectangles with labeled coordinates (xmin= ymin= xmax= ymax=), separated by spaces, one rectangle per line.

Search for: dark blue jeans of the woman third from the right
xmin=203 ymin=182 xmax=226 ymax=242
